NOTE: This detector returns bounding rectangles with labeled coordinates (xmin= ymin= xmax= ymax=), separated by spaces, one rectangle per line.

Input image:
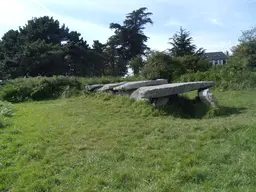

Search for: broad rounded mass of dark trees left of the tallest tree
xmin=0 ymin=16 xmax=107 ymax=79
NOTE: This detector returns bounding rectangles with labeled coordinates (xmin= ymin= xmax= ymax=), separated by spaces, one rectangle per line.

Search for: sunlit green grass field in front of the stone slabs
xmin=0 ymin=91 xmax=256 ymax=192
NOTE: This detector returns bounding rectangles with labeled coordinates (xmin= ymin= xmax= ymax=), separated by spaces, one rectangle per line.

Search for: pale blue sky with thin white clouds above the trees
xmin=0 ymin=0 xmax=256 ymax=52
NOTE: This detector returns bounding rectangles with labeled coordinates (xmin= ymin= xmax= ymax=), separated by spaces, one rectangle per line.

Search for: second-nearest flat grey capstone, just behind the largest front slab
xmin=114 ymin=79 xmax=168 ymax=91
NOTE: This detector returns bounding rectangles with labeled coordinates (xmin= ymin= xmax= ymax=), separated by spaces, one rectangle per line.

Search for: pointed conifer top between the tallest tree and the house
xmin=169 ymin=27 xmax=204 ymax=57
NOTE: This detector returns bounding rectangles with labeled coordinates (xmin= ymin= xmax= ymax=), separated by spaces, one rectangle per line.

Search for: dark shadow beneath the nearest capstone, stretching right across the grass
xmin=158 ymin=96 xmax=246 ymax=119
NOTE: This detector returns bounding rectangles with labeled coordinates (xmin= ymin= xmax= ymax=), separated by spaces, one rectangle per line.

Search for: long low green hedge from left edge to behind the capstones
xmin=0 ymin=76 xmax=144 ymax=103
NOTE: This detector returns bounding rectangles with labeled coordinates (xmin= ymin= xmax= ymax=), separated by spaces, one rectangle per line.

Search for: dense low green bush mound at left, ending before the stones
xmin=1 ymin=76 xmax=83 ymax=103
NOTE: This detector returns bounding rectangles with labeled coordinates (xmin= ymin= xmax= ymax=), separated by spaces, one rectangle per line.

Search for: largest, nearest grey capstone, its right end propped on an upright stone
xmin=130 ymin=81 xmax=215 ymax=100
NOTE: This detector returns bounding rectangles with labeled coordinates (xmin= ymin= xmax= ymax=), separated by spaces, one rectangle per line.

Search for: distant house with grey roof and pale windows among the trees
xmin=204 ymin=52 xmax=229 ymax=66
